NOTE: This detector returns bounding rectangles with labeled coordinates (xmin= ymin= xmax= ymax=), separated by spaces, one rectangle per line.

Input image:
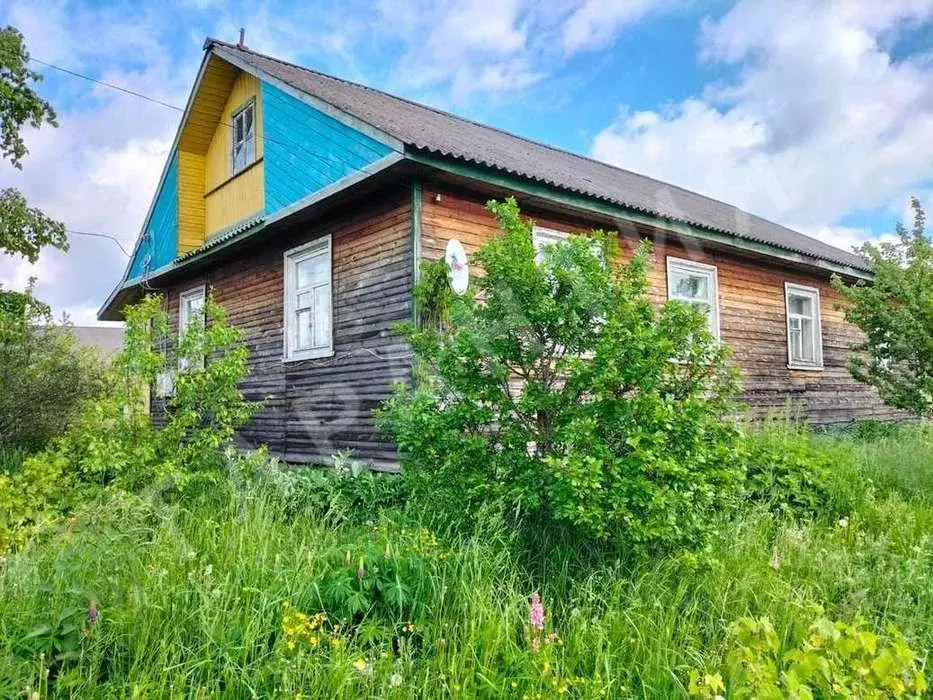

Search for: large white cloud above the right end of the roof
xmin=591 ymin=0 xmax=933 ymax=247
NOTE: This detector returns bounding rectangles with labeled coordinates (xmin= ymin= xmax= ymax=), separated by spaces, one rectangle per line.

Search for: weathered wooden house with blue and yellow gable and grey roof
xmin=99 ymin=39 xmax=892 ymax=465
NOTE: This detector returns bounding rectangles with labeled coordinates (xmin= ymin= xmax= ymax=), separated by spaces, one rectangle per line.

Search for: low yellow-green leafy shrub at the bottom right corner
xmin=689 ymin=616 xmax=926 ymax=698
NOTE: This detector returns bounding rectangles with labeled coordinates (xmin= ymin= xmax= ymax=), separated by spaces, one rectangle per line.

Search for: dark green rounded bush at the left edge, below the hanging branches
xmin=0 ymin=280 xmax=104 ymax=449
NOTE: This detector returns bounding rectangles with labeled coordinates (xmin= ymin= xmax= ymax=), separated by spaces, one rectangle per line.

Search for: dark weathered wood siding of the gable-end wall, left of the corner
xmin=154 ymin=187 xmax=413 ymax=466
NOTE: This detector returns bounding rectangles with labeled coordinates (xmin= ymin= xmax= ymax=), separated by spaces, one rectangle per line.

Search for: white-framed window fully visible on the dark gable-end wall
xmin=285 ymin=236 xmax=333 ymax=360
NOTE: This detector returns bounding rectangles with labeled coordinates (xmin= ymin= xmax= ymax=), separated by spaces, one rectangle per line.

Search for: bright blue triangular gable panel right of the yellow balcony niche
xmin=262 ymin=82 xmax=392 ymax=215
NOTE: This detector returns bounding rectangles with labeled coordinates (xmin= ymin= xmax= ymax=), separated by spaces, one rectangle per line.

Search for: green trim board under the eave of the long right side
xmin=406 ymin=151 xmax=873 ymax=280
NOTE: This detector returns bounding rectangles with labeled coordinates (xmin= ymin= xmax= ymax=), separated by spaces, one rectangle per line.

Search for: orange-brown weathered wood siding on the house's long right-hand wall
xmin=421 ymin=185 xmax=897 ymax=424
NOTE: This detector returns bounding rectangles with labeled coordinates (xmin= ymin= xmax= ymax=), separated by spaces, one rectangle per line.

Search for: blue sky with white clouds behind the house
xmin=0 ymin=0 xmax=933 ymax=325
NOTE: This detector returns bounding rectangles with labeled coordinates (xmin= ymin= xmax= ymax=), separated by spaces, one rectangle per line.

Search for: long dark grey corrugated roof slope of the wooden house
xmin=205 ymin=39 xmax=868 ymax=270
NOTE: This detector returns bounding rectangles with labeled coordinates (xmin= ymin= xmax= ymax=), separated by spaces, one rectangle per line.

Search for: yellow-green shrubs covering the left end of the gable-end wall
xmin=0 ymin=296 xmax=256 ymax=550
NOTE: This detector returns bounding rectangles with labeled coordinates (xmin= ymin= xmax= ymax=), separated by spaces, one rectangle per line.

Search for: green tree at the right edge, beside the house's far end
xmin=833 ymin=198 xmax=933 ymax=417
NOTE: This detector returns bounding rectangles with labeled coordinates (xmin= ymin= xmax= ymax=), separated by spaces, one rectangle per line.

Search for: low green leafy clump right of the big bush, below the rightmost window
xmin=742 ymin=420 xmax=854 ymax=518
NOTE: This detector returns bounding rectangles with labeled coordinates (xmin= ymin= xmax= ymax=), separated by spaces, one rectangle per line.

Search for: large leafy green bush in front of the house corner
xmin=380 ymin=199 xmax=741 ymax=547
